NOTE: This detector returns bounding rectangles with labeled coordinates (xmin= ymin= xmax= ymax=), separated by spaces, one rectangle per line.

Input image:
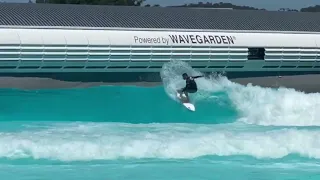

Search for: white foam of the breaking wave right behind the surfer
xmin=220 ymin=82 xmax=320 ymax=126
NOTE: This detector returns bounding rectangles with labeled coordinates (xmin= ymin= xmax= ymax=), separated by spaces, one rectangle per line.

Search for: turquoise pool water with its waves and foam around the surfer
xmin=0 ymin=62 xmax=320 ymax=180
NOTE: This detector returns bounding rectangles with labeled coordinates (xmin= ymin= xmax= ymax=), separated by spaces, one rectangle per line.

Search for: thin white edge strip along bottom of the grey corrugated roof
xmin=0 ymin=25 xmax=320 ymax=34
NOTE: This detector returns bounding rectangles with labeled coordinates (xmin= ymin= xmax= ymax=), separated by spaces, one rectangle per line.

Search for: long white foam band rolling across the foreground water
xmin=0 ymin=123 xmax=320 ymax=161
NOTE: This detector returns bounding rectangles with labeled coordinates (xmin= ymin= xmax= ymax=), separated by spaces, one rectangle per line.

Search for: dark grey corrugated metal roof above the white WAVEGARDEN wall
xmin=0 ymin=3 xmax=320 ymax=32
